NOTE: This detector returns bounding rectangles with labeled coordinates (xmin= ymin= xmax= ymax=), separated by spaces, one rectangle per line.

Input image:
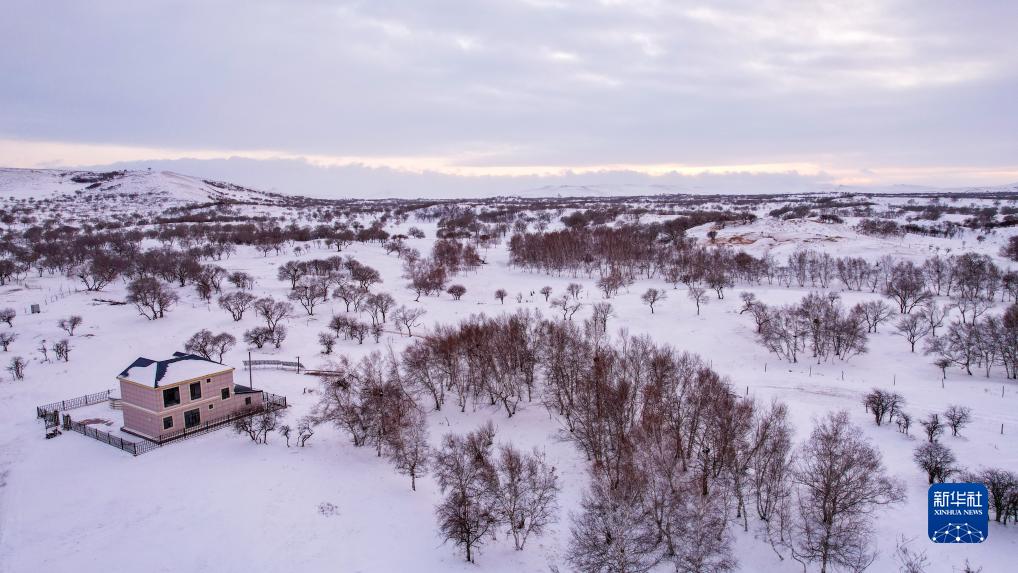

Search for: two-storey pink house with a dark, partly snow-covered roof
xmin=117 ymin=352 xmax=264 ymax=443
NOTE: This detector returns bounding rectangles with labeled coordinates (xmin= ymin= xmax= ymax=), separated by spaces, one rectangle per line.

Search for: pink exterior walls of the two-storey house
xmin=120 ymin=370 xmax=262 ymax=439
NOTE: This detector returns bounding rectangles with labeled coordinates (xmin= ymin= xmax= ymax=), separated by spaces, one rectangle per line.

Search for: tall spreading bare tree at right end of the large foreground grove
xmin=792 ymin=412 xmax=904 ymax=572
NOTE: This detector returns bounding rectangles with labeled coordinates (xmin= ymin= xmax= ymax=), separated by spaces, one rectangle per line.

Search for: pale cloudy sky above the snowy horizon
xmin=0 ymin=0 xmax=1018 ymax=195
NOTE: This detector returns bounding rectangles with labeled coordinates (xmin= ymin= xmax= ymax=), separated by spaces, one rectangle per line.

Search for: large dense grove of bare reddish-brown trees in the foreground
xmin=309 ymin=311 xmax=903 ymax=572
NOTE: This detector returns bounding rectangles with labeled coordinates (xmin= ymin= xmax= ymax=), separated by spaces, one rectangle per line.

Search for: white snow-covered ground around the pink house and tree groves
xmin=0 ymin=176 xmax=1018 ymax=573
